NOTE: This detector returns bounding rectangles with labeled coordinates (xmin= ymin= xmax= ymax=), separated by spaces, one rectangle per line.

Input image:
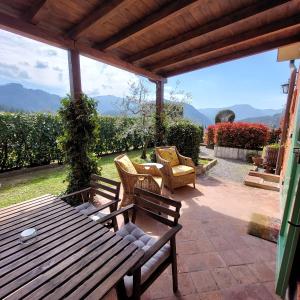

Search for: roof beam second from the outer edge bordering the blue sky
xmin=150 ymin=14 xmax=300 ymax=71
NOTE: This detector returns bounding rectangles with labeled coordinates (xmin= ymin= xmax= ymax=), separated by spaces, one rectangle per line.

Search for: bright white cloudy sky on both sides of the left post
xmin=0 ymin=30 xmax=138 ymax=97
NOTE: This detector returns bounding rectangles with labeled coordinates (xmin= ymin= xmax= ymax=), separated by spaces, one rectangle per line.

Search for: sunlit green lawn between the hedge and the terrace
xmin=0 ymin=149 xmax=151 ymax=207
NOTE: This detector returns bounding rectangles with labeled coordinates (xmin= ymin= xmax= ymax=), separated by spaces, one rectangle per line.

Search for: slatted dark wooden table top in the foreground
xmin=0 ymin=195 xmax=144 ymax=299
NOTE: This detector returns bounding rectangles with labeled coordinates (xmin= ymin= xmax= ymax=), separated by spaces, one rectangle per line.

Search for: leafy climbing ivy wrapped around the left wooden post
xmin=59 ymin=94 xmax=99 ymax=205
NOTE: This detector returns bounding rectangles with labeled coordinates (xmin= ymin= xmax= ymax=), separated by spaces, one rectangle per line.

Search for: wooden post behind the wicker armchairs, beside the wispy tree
xmin=155 ymin=80 xmax=166 ymax=146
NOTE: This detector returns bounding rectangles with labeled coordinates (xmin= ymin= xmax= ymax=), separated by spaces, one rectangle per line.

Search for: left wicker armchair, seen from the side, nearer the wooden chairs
xmin=114 ymin=154 xmax=163 ymax=206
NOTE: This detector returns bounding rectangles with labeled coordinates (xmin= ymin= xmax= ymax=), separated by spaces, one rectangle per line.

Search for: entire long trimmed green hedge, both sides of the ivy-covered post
xmin=0 ymin=113 xmax=153 ymax=172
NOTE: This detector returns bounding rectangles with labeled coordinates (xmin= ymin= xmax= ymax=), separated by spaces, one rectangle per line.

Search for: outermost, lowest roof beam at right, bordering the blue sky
xmin=161 ymin=33 xmax=300 ymax=78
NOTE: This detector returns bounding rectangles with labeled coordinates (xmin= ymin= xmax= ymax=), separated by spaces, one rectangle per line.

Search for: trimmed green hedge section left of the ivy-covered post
xmin=0 ymin=113 xmax=62 ymax=171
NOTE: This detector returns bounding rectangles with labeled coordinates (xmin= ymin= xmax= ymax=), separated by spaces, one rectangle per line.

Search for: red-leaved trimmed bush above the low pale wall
xmin=214 ymin=122 xmax=269 ymax=149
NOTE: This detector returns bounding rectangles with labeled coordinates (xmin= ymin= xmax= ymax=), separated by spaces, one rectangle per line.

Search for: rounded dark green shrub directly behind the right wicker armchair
xmin=166 ymin=120 xmax=203 ymax=165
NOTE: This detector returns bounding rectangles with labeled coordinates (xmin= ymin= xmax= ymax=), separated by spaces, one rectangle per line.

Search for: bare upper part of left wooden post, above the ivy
xmin=68 ymin=50 xmax=82 ymax=101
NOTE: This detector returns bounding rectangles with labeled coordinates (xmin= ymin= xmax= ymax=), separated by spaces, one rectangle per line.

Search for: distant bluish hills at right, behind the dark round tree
xmin=198 ymin=104 xmax=282 ymax=123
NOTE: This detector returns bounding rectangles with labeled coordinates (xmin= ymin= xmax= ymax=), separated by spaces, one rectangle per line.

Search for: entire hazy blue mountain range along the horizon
xmin=0 ymin=83 xmax=282 ymax=127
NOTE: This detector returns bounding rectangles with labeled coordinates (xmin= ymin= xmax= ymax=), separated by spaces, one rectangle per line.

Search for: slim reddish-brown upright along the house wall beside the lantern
xmin=275 ymin=61 xmax=297 ymax=175
